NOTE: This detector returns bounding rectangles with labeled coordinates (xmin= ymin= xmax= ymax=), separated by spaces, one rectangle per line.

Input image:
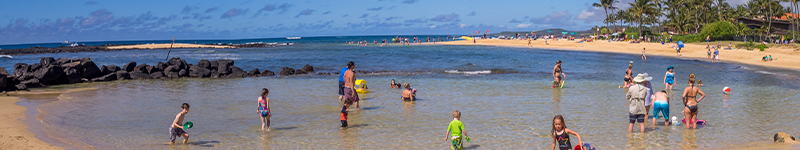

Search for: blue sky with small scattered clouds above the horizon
xmin=0 ymin=0 xmax=764 ymax=45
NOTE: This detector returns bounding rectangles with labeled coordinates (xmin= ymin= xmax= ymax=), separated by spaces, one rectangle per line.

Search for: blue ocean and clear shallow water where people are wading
xmin=0 ymin=37 xmax=800 ymax=149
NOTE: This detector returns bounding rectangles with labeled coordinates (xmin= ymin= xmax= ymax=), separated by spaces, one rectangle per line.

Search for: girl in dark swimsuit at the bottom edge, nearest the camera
xmin=551 ymin=115 xmax=583 ymax=150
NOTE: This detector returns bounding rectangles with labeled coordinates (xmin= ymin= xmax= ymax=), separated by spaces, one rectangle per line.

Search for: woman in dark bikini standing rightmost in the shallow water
xmin=683 ymin=74 xmax=706 ymax=129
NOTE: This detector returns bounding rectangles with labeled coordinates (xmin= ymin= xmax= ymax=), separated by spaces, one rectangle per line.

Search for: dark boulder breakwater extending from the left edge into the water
xmin=0 ymin=57 xmax=318 ymax=91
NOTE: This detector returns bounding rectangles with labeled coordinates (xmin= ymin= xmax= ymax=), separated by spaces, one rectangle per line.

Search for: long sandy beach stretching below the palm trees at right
xmin=437 ymin=39 xmax=800 ymax=69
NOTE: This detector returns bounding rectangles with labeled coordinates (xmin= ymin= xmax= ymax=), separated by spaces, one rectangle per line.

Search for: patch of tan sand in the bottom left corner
xmin=0 ymin=97 xmax=62 ymax=149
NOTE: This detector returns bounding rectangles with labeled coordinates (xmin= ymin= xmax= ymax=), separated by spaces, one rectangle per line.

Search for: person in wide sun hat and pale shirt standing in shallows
xmin=625 ymin=74 xmax=647 ymax=132
